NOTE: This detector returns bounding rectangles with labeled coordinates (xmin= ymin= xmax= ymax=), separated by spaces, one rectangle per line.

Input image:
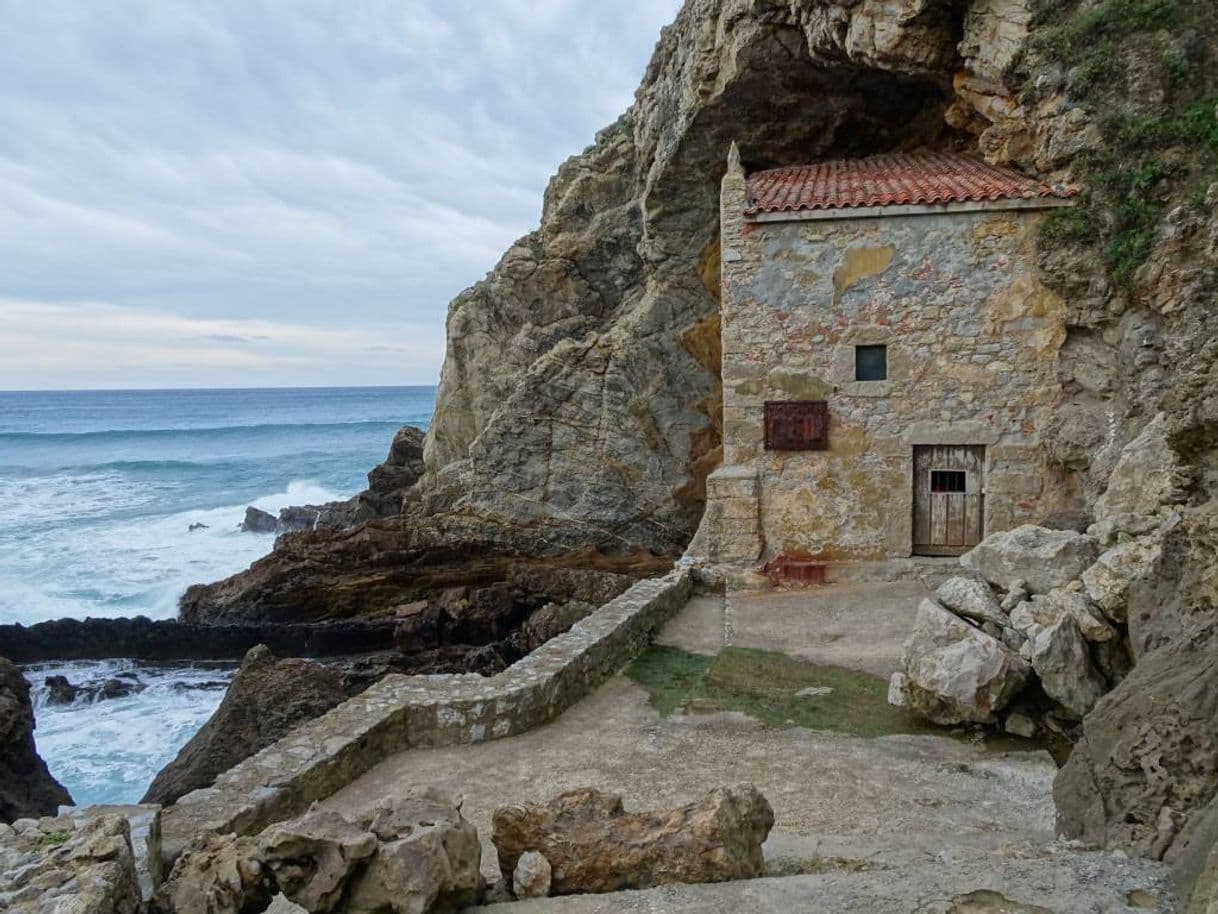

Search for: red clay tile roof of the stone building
xmin=745 ymin=152 xmax=1077 ymax=216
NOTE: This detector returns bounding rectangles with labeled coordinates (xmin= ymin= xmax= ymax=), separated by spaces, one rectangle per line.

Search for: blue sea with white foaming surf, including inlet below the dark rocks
xmin=0 ymin=386 xmax=435 ymax=804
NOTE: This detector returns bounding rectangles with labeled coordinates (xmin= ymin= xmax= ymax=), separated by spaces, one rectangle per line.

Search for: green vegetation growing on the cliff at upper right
xmin=1024 ymin=0 xmax=1218 ymax=285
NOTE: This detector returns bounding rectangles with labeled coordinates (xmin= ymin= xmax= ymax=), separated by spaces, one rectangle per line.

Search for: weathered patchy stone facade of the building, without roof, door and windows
xmin=694 ymin=150 xmax=1077 ymax=580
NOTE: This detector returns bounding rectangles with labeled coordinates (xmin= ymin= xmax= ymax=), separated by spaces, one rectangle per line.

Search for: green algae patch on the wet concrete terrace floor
xmin=627 ymin=646 xmax=942 ymax=736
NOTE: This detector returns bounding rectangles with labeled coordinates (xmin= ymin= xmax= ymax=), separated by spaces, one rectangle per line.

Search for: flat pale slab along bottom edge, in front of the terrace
xmin=470 ymin=848 xmax=1174 ymax=914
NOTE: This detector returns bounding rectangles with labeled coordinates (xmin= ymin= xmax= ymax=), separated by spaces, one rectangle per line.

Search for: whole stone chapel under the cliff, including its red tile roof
xmin=694 ymin=146 xmax=1072 ymax=580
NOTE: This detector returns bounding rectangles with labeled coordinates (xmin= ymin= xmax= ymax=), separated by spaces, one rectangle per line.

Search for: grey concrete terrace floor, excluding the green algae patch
xmin=302 ymin=584 xmax=1170 ymax=914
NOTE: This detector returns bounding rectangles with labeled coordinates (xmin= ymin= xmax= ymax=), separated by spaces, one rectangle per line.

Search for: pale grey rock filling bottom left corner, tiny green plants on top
xmin=0 ymin=815 xmax=144 ymax=914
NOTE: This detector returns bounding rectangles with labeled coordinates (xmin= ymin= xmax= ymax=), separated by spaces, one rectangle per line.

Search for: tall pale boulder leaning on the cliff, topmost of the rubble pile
xmin=1094 ymin=413 xmax=1188 ymax=542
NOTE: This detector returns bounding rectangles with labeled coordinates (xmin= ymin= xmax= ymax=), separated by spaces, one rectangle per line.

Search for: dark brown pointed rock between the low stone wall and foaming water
xmin=141 ymin=645 xmax=347 ymax=806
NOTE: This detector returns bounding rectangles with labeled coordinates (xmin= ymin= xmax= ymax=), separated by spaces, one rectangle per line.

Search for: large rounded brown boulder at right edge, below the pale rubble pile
xmin=1054 ymin=622 xmax=1218 ymax=862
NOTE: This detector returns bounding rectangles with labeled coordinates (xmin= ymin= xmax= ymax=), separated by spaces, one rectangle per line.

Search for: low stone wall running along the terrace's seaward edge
xmin=162 ymin=568 xmax=693 ymax=865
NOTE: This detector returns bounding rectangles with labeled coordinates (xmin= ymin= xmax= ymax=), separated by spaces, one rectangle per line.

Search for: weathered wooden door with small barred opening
xmin=914 ymin=445 xmax=985 ymax=556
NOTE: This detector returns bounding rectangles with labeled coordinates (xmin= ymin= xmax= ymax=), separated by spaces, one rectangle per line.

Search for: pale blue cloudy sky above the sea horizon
xmin=0 ymin=0 xmax=680 ymax=390
